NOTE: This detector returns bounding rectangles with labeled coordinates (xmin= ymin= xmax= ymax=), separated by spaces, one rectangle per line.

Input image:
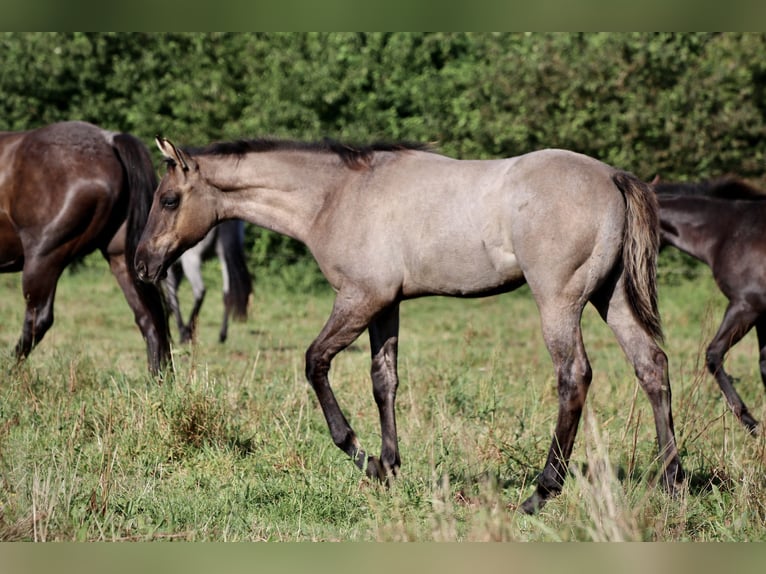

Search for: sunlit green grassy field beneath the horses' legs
xmin=0 ymin=260 xmax=766 ymax=541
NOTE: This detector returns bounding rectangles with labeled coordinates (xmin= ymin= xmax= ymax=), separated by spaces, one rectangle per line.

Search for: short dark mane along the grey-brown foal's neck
xmin=185 ymin=138 xmax=432 ymax=169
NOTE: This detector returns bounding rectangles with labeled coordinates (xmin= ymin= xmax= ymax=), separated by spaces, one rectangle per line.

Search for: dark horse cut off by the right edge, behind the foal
xmin=653 ymin=177 xmax=766 ymax=432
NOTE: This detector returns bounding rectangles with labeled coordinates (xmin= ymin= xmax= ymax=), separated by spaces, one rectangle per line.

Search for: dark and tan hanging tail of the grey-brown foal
xmin=612 ymin=172 xmax=663 ymax=341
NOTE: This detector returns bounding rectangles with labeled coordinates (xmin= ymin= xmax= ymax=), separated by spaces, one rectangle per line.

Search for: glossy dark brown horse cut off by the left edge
xmin=0 ymin=122 xmax=170 ymax=372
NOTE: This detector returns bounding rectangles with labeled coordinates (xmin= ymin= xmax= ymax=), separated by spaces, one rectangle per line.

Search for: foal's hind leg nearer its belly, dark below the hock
xmin=520 ymin=303 xmax=592 ymax=514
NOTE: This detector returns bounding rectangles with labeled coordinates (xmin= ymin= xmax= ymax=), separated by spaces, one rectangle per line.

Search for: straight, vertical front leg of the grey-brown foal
xmin=369 ymin=303 xmax=401 ymax=484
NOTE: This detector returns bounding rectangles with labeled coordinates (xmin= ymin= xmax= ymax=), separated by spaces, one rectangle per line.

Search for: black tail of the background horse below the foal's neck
xmin=218 ymin=219 xmax=253 ymax=321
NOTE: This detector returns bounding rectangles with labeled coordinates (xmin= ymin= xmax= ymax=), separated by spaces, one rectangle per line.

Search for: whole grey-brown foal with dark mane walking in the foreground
xmin=136 ymin=139 xmax=683 ymax=512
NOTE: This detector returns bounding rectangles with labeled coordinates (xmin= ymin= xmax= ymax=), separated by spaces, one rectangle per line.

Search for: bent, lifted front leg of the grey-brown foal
xmin=306 ymin=290 xmax=388 ymax=478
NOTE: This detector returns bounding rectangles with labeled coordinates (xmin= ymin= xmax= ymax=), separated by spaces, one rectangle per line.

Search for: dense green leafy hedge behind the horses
xmin=0 ymin=33 xmax=766 ymax=286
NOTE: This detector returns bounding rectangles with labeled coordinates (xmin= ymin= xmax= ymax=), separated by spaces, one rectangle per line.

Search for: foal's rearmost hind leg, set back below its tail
xmin=594 ymin=290 xmax=684 ymax=493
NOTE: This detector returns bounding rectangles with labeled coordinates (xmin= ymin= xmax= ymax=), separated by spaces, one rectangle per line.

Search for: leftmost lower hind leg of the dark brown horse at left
xmin=15 ymin=258 xmax=64 ymax=360
